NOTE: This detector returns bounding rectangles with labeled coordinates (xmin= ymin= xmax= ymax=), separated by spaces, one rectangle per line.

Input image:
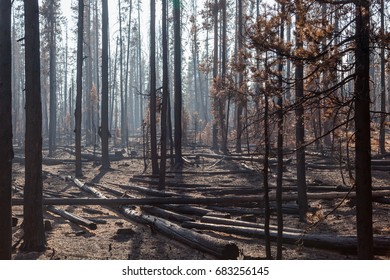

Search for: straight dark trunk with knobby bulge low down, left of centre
xmin=101 ymin=0 xmax=110 ymax=170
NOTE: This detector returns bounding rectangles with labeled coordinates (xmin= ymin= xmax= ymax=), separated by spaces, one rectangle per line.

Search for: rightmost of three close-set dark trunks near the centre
xmin=173 ymin=0 xmax=183 ymax=168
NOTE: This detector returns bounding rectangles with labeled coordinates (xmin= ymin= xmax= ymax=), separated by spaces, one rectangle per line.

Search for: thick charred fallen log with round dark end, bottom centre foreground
xmin=122 ymin=207 xmax=239 ymax=259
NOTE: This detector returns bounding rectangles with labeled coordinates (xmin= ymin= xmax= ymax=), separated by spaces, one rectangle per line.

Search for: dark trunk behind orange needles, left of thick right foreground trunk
xmin=295 ymin=0 xmax=308 ymax=222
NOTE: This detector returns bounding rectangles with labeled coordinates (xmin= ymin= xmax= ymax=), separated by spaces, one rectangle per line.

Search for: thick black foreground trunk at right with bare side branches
xmin=355 ymin=0 xmax=373 ymax=259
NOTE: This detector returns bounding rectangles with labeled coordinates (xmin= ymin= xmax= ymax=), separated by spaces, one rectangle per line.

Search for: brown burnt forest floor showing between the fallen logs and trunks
xmin=9 ymin=144 xmax=390 ymax=260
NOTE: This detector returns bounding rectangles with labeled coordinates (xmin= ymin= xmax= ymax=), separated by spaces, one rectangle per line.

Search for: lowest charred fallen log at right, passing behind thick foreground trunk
xmin=183 ymin=222 xmax=390 ymax=255
